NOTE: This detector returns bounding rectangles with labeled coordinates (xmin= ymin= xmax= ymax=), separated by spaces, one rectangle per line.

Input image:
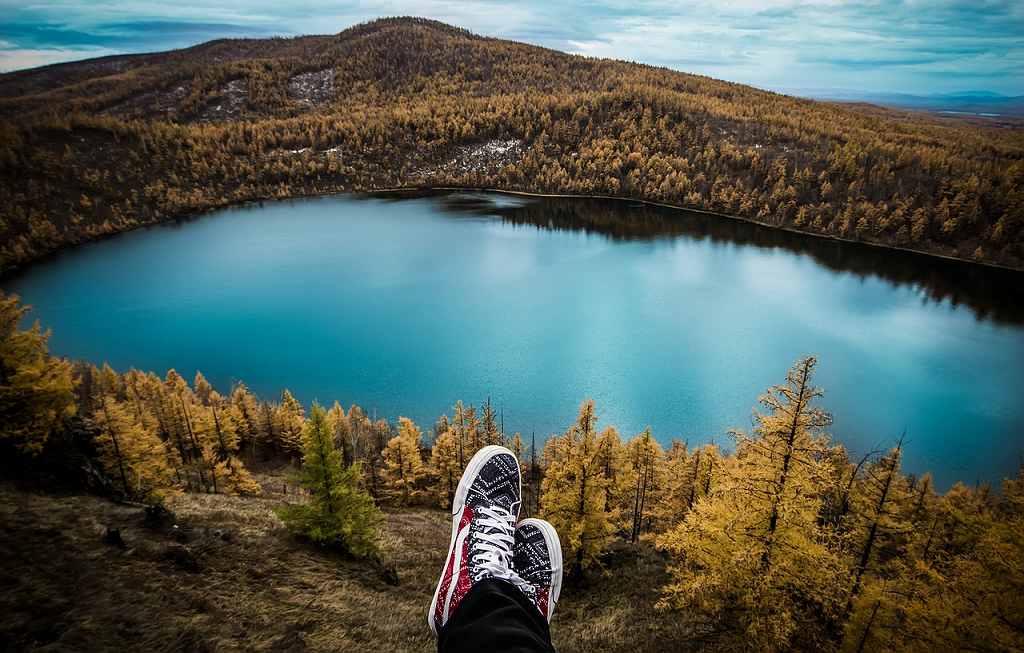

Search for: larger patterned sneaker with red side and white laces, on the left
xmin=427 ymin=445 xmax=526 ymax=635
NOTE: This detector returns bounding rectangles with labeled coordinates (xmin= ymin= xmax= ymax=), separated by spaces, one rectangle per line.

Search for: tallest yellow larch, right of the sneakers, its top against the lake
xmin=658 ymin=358 xmax=847 ymax=650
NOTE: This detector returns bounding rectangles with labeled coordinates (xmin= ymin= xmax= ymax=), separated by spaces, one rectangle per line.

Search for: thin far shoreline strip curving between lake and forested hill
xmin=0 ymin=184 xmax=1024 ymax=284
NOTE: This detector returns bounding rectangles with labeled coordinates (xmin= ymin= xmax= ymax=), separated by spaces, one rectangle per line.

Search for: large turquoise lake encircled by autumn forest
xmin=0 ymin=193 xmax=1024 ymax=487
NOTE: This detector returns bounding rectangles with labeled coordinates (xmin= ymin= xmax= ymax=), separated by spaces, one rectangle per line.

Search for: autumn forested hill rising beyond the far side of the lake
xmin=0 ymin=18 xmax=1024 ymax=270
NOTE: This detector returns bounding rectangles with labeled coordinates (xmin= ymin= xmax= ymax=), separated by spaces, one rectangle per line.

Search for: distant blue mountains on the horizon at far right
xmin=790 ymin=89 xmax=1024 ymax=117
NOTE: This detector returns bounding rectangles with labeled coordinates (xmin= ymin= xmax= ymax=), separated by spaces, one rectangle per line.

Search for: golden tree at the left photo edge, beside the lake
xmin=0 ymin=292 xmax=75 ymax=453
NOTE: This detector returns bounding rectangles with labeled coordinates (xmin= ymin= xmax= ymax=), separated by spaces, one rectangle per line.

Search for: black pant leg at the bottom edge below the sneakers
xmin=437 ymin=578 xmax=555 ymax=653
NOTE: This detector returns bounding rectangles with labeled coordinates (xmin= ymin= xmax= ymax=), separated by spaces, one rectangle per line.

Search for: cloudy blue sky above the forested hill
xmin=0 ymin=0 xmax=1024 ymax=95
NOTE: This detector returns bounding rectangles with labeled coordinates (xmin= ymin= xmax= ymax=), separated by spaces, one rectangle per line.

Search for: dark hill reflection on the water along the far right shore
xmin=374 ymin=191 xmax=1024 ymax=324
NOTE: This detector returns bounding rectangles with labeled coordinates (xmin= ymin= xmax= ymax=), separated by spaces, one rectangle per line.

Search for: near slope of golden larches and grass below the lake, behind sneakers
xmin=0 ymin=295 xmax=1024 ymax=651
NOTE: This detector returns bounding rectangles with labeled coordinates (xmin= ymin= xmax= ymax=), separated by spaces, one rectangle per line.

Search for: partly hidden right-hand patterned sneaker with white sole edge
xmin=512 ymin=519 xmax=562 ymax=623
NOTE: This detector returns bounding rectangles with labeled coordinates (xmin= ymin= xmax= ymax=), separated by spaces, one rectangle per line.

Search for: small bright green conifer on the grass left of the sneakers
xmin=279 ymin=404 xmax=380 ymax=557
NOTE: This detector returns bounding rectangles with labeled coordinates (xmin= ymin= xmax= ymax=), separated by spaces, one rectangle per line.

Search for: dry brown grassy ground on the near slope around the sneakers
xmin=0 ymin=474 xmax=699 ymax=652
